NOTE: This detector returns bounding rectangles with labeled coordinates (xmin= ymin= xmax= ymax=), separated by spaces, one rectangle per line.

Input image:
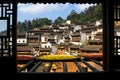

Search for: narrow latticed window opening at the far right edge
xmin=114 ymin=4 xmax=120 ymax=70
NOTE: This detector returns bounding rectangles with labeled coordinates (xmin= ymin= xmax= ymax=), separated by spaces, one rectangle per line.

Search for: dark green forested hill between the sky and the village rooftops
xmin=18 ymin=4 xmax=102 ymax=33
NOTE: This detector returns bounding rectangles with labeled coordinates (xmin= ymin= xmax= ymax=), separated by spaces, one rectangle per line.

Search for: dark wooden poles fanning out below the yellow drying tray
xmin=17 ymin=59 xmax=104 ymax=73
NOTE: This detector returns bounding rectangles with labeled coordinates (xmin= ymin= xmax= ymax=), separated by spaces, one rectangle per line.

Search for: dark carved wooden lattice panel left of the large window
xmin=0 ymin=3 xmax=13 ymax=57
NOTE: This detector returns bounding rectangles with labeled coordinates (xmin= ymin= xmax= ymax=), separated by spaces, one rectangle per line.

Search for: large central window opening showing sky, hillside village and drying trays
xmin=17 ymin=3 xmax=104 ymax=72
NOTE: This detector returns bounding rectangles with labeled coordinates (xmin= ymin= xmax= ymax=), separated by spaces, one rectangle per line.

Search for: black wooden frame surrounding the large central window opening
xmin=0 ymin=0 xmax=117 ymax=80
